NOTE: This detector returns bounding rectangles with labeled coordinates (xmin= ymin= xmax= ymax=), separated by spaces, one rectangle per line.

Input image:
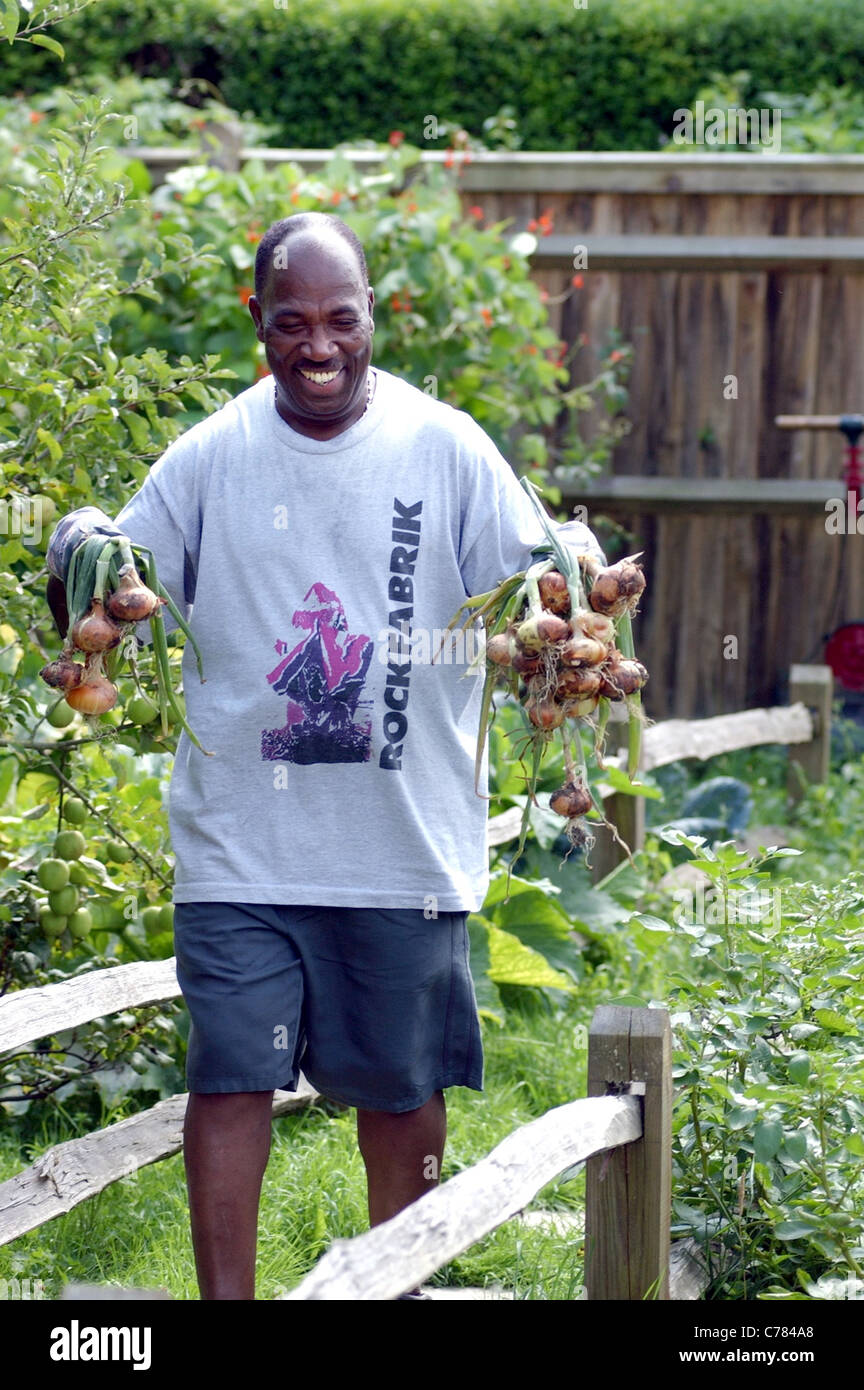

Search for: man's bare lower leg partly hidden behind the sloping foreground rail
xmin=357 ymin=1091 xmax=447 ymax=1226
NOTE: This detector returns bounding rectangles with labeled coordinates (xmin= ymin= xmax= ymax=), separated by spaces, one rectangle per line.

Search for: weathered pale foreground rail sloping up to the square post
xmin=283 ymin=1095 xmax=642 ymax=1301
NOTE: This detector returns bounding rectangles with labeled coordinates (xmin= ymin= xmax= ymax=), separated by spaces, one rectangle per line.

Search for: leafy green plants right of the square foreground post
xmin=632 ymin=831 xmax=864 ymax=1298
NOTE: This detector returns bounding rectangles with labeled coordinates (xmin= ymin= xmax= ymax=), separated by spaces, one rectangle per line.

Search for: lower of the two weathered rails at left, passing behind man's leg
xmin=0 ymin=1074 xmax=318 ymax=1245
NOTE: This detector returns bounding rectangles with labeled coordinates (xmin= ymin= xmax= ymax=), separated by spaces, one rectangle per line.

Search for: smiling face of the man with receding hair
xmin=249 ymin=232 xmax=375 ymax=439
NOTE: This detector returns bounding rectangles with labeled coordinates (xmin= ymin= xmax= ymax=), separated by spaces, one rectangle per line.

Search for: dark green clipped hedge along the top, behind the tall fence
xmin=6 ymin=0 xmax=864 ymax=150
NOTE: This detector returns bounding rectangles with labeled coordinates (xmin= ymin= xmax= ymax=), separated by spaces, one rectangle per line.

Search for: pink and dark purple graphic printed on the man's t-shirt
xmin=261 ymin=582 xmax=374 ymax=763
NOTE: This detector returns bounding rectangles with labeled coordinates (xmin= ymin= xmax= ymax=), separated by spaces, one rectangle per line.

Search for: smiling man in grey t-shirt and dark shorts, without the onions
xmin=49 ymin=213 xmax=601 ymax=1298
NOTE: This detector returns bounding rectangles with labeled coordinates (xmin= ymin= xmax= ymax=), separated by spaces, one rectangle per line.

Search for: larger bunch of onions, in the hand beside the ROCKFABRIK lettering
xmin=450 ymin=478 xmax=647 ymax=889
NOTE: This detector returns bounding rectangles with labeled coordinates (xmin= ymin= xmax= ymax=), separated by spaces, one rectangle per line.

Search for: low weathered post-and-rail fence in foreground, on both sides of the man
xmin=0 ymin=989 xmax=691 ymax=1301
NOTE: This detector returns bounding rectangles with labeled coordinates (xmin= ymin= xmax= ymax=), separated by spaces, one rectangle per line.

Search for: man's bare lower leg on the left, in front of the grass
xmin=183 ymin=1091 xmax=274 ymax=1300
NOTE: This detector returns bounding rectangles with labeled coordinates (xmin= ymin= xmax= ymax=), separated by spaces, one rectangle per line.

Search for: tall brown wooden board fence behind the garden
xmin=135 ymin=143 xmax=864 ymax=719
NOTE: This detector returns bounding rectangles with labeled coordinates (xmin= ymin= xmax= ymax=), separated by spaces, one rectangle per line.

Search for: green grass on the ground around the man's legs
xmin=0 ymin=995 xmax=588 ymax=1301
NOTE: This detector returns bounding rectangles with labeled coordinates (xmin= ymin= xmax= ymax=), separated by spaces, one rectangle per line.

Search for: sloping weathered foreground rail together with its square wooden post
xmin=277 ymin=1005 xmax=672 ymax=1301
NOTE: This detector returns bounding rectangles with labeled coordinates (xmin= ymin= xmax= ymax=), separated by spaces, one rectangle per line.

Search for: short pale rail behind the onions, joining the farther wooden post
xmin=642 ymin=703 xmax=813 ymax=769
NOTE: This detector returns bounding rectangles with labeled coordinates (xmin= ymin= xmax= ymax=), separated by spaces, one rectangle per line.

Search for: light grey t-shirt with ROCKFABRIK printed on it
xmin=57 ymin=370 xmax=601 ymax=916
